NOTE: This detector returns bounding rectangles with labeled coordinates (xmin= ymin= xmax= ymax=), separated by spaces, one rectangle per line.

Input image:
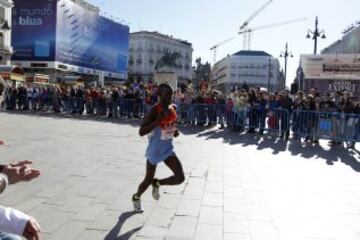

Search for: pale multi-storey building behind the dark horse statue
xmin=128 ymin=31 xmax=193 ymax=83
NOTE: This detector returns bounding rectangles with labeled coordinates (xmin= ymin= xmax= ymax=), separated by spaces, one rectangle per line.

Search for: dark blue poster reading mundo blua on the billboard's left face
xmin=12 ymin=0 xmax=56 ymax=61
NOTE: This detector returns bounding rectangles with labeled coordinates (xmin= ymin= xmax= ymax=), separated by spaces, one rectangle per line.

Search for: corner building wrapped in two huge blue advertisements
xmin=10 ymin=0 xmax=129 ymax=85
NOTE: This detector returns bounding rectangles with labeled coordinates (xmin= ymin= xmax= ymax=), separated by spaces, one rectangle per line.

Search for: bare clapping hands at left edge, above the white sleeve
xmin=3 ymin=160 xmax=40 ymax=184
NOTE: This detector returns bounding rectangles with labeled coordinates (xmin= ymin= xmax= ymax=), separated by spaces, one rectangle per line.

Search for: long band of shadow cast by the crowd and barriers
xmin=0 ymin=111 xmax=360 ymax=172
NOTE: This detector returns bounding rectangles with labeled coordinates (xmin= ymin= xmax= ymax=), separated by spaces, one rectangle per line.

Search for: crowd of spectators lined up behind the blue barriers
xmin=1 ymin=81 xmax=360 ymax=147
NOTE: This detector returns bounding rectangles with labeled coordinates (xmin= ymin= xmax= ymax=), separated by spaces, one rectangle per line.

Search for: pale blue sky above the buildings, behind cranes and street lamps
xmin=89 ymin=0 xmax=360 ymax=85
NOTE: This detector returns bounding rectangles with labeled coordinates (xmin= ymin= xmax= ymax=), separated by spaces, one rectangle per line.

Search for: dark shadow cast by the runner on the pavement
xmin=104 ymin=211 xmax=142 ymax=240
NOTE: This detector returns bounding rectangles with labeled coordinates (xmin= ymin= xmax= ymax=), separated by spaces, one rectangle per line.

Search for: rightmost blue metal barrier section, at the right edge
xmin=292 ymin=110 xmax=360 ymax=142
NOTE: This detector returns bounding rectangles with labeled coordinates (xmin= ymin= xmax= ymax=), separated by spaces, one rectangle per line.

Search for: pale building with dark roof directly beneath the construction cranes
xmin=210 ymin=51 xmax=284 ymax=94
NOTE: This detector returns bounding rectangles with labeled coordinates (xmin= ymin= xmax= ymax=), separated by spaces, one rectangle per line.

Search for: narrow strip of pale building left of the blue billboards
xmin=0 ymin=0 xmax=13 ymax=65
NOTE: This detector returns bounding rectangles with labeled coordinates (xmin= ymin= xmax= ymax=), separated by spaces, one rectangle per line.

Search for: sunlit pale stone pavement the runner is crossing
xmin=0 ymin=113 xmax=360 ymax=240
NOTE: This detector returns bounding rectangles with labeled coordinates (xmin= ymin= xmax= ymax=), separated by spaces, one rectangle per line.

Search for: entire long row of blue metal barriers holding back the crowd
xmin=4 ymin=94 xmax=360 ymax=142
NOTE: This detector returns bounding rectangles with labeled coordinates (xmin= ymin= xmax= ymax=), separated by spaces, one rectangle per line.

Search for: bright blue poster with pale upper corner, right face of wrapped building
xmin=56 ymin=0 xmax=129 ymax=74
